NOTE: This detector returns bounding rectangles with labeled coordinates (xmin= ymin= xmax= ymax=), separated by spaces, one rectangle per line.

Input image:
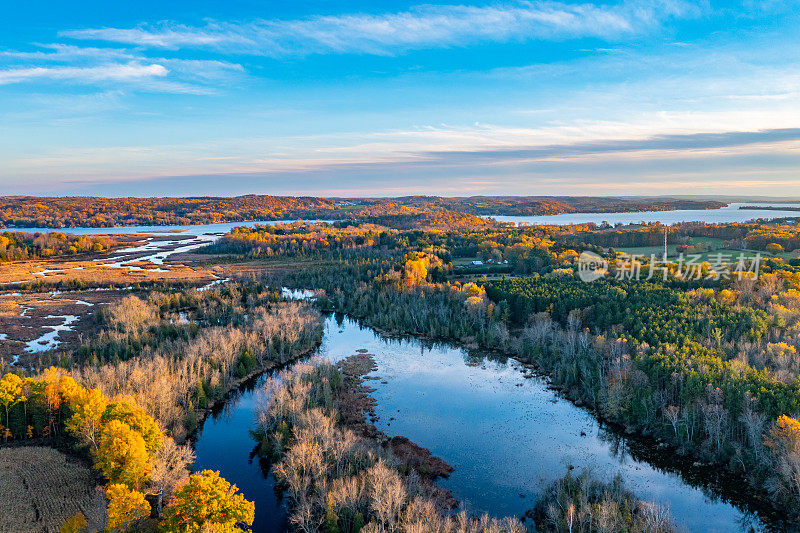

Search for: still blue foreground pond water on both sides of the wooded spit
xmin=195 ymin=316 xmax=761 ymax=532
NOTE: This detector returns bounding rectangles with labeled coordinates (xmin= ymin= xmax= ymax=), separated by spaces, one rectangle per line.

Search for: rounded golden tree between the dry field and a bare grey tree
xmin=95 ymin=420 xmax=150 ymax=488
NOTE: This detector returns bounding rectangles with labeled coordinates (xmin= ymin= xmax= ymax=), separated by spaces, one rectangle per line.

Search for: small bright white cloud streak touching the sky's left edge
xmin=0 ymin=63 xmax=169 ymax=85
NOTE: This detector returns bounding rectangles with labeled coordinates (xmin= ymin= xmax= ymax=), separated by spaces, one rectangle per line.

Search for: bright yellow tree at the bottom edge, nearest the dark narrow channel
xmin=163 ymin=470 xmax=255 ymax=533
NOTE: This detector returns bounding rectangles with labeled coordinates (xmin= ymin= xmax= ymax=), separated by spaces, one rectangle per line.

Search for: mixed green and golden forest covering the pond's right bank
xmin=250 ymin=218 xmax=800 ymax=516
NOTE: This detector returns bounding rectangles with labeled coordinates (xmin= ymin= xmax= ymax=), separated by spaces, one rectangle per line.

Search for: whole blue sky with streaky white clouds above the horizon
xmin=0 ymin=0 xmax=800 ymax=197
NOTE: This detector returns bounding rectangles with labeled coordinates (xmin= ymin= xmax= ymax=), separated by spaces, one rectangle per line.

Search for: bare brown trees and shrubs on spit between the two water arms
xmin=254 ymin=352 xmax=523 ymax=533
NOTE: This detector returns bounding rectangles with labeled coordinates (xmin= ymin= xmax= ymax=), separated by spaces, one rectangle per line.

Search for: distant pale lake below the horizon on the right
xmin=483 ymin=202 xmax=800 ymax=226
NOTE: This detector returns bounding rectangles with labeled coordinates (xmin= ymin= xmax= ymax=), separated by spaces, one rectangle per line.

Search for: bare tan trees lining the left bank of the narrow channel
xmin=76 ymin=294 xmax=321 ymax=439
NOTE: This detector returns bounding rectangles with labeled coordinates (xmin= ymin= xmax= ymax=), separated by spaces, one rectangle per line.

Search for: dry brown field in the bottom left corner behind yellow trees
xmin=0 ymin=446 xmax=105 ymax=533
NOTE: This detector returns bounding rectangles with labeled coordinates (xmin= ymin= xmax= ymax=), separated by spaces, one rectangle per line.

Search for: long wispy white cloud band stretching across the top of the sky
xmin=60 ymin=0 xmax=699 ymax=57
